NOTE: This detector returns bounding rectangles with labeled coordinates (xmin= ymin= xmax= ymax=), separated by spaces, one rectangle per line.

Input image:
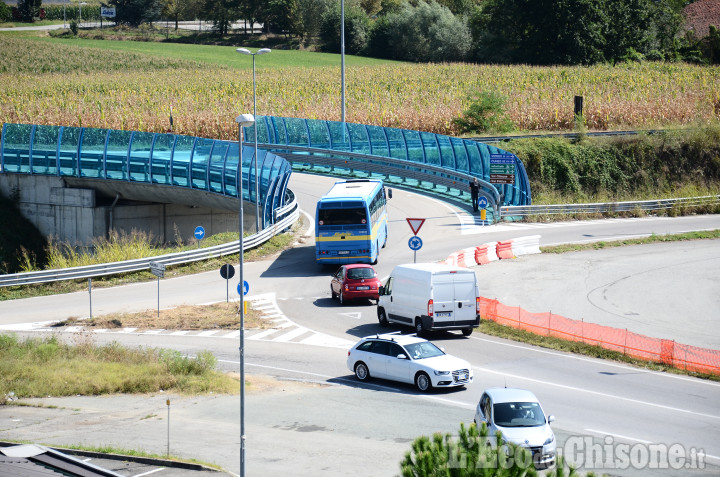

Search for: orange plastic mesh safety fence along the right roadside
xmin=480 ymin=297 xmax=720 ymax=374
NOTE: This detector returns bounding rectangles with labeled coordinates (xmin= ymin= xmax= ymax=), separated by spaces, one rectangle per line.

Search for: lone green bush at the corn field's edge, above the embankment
xmin=453 ymin=91 xmax=515 ymax=133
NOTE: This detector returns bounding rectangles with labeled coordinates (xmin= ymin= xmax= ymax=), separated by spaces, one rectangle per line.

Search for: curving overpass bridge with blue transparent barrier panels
xmin=0 ymin=116 xmax=531 ymax=244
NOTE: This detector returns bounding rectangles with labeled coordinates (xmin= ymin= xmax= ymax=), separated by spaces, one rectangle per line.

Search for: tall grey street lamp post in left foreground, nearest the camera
xmin=235 ymin=114 xmax=255 ymax=477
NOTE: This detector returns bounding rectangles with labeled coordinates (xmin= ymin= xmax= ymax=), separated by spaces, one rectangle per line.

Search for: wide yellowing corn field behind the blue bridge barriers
xmin=0 ymin=36 xmax=720 ymax=139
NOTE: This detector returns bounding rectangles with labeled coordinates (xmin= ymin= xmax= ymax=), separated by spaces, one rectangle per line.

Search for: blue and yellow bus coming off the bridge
xmin=315 ymin=179 xmax=392 ymax=264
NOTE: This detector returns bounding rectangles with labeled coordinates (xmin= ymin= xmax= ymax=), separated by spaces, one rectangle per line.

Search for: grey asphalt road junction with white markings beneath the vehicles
xmin=0 ymin=174 xmax=720 ymax=476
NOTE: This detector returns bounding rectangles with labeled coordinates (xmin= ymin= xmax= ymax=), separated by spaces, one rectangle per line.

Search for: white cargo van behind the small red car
xmin=377 ymin=263 xmax=480 ymax=336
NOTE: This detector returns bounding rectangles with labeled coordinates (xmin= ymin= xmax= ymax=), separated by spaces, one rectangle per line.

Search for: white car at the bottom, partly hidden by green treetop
xmin=474 ymin=388 xmax=557 ymax=468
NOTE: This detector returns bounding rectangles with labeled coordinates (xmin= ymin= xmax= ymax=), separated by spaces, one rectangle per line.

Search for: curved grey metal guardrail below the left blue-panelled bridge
xmin=0 ymin=196 xmax=300 ymax=287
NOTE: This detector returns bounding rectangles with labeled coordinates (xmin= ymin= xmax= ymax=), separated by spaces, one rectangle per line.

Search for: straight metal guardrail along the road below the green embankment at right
xmin=500 ymin=195 xmax=720 ymax=218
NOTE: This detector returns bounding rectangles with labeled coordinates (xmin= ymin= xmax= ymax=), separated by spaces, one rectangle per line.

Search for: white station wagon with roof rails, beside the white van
xmin=347 ymin=333 xmax=473 ymax=392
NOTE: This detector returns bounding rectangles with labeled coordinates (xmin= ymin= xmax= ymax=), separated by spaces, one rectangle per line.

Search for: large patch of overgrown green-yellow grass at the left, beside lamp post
xmin=0 ymin=335 xmax=239 ymax=401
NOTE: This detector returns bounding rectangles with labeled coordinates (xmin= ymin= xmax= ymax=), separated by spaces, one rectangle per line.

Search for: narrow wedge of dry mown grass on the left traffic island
xmin=55 ymin=302 xmax=271 ymax=331
